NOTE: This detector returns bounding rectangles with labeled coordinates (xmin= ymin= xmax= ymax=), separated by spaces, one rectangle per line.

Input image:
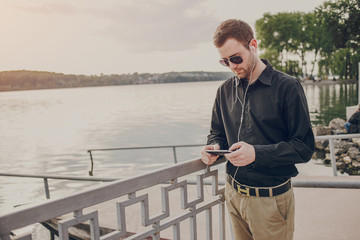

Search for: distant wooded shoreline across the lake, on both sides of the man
xmin=0 ymin=70 xmax=357 ymax=92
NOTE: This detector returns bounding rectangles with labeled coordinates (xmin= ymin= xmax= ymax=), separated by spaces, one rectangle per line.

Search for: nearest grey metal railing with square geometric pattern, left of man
xmin=0 ymin=159 xmax=225 ymax=240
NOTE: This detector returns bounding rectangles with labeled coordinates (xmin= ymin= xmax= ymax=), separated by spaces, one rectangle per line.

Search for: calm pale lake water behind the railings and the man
xmin=0 ymin=81 xmax=357 ymax=214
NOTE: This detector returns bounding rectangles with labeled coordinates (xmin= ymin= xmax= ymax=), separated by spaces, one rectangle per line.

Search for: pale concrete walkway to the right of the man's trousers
xmin=294 ymin=177 xmax=360 ymax=240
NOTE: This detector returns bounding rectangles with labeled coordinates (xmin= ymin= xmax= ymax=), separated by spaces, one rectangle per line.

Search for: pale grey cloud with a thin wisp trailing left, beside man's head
xmin=8 ymin=0 xmax=219 ymax=52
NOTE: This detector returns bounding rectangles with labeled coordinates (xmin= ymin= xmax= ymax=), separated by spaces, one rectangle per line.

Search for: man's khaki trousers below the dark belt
xmin=225 ymin=182 xmax=295 ymax=240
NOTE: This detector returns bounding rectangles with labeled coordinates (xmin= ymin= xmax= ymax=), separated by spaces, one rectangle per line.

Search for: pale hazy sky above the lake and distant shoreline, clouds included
xmin=0 ymin=0 xmax=325 ymax=75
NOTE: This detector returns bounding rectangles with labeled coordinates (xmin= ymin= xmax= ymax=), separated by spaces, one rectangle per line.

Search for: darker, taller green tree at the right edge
xmin=315 ymin=0 xmax=360 ymax=79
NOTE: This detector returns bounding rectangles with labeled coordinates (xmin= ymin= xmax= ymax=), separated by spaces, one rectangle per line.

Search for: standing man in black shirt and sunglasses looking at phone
xmin=201 ymin=19 xmax=314 ymax=240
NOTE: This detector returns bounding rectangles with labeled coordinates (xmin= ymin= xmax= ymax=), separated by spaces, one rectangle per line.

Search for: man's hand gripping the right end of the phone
xmin=225 ymin=142 xmax=255 ymax=167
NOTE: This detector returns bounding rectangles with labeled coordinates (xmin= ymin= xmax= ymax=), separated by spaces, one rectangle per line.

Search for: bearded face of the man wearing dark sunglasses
xmin=218 ymin=38 xmax=254 ymax=80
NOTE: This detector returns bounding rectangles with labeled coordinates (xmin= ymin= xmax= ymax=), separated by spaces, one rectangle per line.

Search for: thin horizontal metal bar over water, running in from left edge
xmin=0 ymin=172 xmax=116 ymax=182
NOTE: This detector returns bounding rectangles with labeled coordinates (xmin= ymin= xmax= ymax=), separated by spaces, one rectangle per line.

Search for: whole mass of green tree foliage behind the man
xmin=255 ymin=0 xmax=360 ymax=79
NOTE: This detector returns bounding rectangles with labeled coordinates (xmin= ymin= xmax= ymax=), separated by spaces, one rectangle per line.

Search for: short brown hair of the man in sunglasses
xmin=214 ymin=19 xmax=254 ymax=48
